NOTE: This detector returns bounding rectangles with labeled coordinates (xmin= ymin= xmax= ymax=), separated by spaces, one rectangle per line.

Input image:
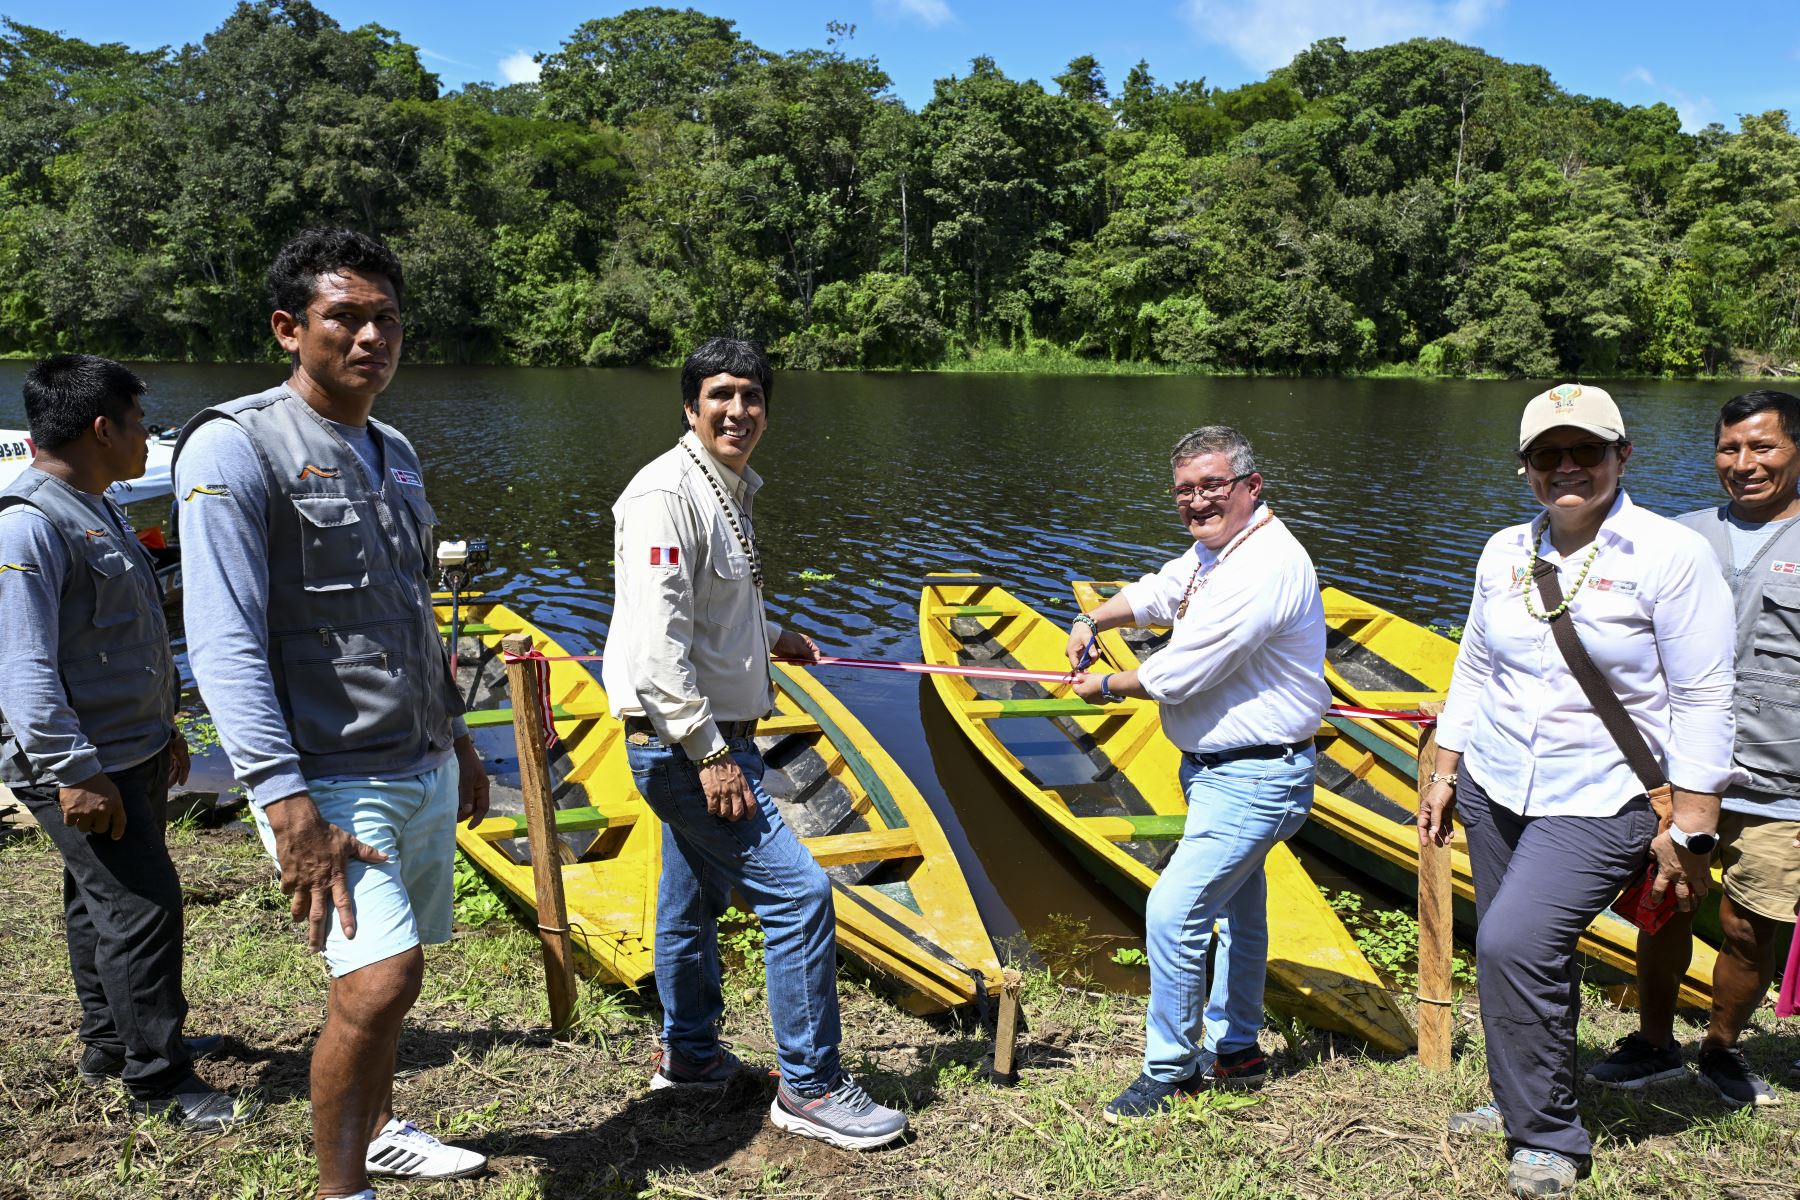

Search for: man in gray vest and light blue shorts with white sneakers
xmin=175 ymin=228 xmax=488 ymax=1200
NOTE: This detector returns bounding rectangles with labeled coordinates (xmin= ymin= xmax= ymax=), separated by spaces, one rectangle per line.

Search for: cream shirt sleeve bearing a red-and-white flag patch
xmin=607 ymin=491 xmax=725 ymax=761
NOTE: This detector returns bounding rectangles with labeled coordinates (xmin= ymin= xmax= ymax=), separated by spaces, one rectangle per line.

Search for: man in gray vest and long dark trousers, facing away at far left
xmin=0 ymin=354 xmax=256 ymax=1130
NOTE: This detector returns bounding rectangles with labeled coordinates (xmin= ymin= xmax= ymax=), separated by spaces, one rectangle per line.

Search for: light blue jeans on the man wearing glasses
xmin=1143 ymin=747 xmax=1316 ymax=1083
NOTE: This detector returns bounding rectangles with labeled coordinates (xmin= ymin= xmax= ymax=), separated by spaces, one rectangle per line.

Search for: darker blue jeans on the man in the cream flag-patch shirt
xmin=626 ymin=738 xmax=842 ymax=1096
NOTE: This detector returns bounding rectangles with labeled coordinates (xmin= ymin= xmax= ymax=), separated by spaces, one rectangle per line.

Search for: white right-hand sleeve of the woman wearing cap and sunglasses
xmin=1651 ymin=536 xmax=1737 ymax=793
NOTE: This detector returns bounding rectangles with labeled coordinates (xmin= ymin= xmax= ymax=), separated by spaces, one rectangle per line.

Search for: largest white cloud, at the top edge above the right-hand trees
xmin=1181 ymin=0 xmax=1505 ymax=70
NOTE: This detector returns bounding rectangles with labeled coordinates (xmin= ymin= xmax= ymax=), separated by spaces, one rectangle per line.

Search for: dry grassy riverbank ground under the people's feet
xmin=0 ymin=822 xmax=1800 ymax=1200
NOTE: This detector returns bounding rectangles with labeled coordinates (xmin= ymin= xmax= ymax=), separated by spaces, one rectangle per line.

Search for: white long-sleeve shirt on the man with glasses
xmin=1121 ymin=506 xmax=1330 ymax=754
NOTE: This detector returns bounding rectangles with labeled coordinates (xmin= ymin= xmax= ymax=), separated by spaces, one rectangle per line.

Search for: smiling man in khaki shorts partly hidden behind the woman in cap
xmin=1588 ymin=392 xmax=1800 ymax=1108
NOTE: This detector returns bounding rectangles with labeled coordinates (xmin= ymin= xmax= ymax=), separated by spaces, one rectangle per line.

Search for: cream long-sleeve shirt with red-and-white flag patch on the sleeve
xmin=601 ymin=432 xmax=781 ymax=759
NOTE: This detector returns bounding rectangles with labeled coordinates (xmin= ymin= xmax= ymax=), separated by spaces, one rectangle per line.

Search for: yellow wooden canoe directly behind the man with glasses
xmin=920 ymin=574 xmax=1415 ymax=1051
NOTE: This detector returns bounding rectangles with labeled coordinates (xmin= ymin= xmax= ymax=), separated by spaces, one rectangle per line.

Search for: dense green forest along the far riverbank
xmin=0 ymin=0 xmax=1800 ymax=376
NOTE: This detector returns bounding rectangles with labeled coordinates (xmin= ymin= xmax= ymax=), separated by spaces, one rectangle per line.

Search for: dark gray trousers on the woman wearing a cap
xmin=1456 ymin=768 xmax=1656 ymax=1166
